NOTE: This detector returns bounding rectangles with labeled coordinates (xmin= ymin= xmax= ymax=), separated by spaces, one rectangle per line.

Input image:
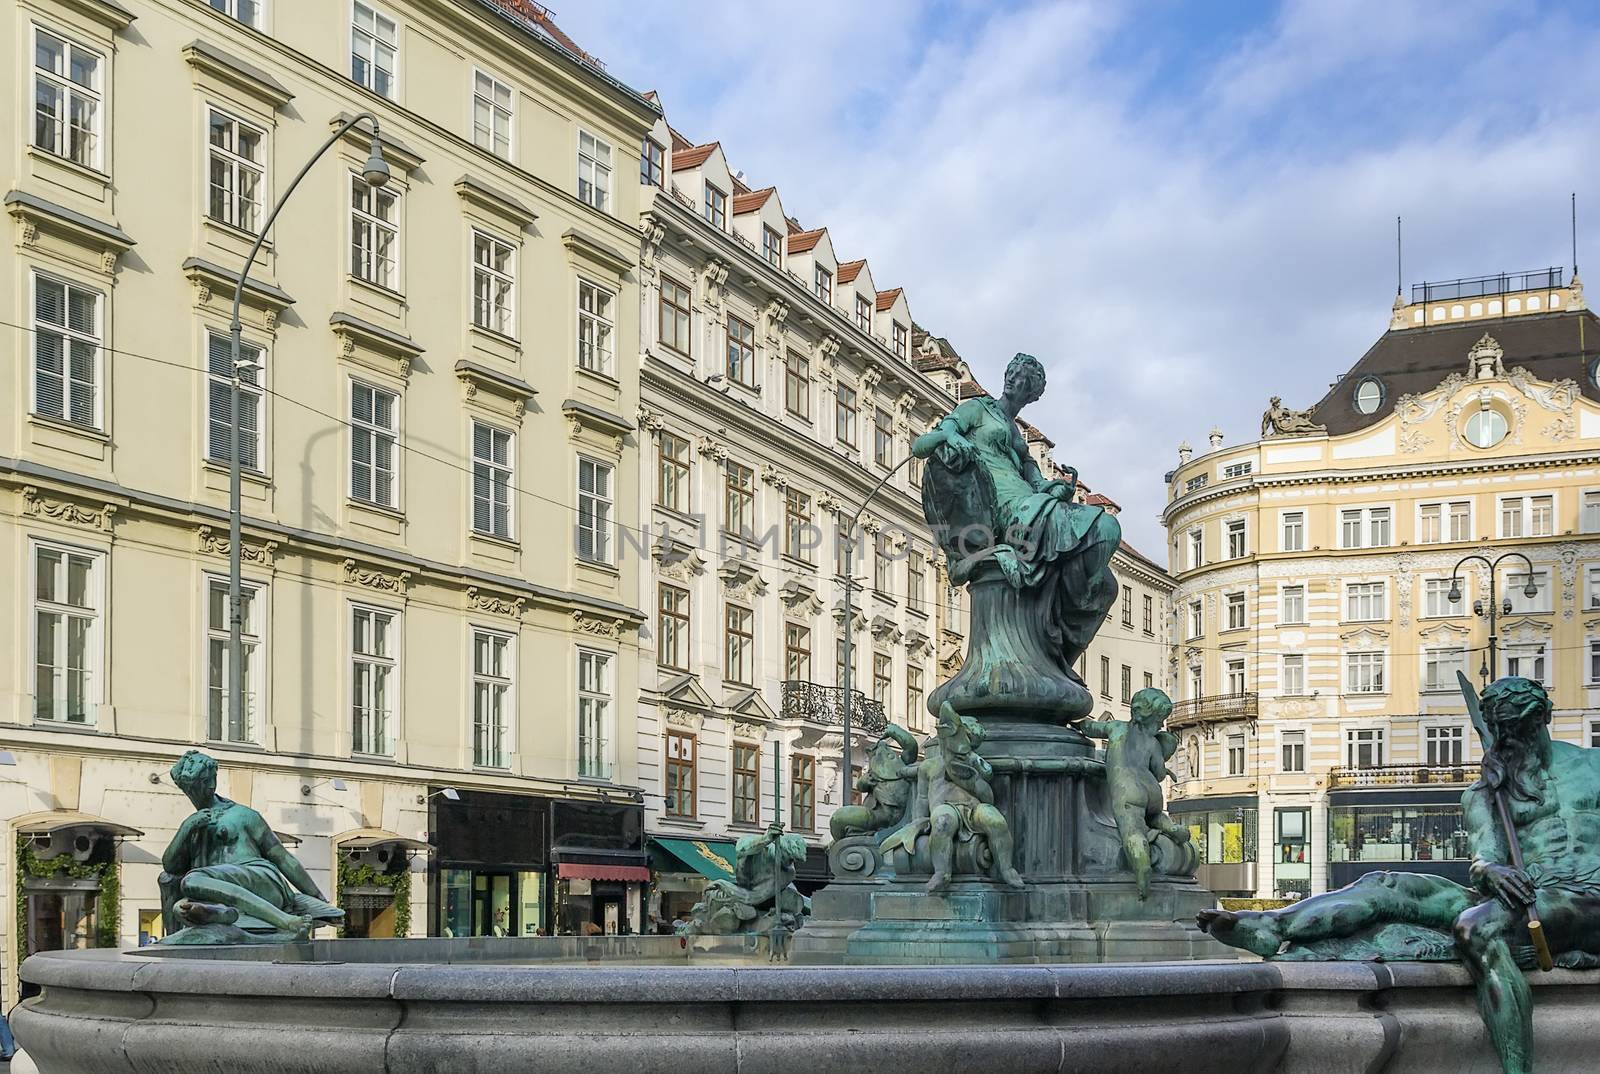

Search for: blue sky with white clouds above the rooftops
xmin=557 ymin=0 xmax=1600 ymax=559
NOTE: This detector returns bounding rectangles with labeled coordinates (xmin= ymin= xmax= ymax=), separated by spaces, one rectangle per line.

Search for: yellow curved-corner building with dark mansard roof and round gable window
xmin=1163 ymin=269 xmax=1600 ymax=898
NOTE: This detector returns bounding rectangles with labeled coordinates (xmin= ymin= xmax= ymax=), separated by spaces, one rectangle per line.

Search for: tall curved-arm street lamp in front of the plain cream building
xmin=227 ymin=112 xmax=389 ymax=749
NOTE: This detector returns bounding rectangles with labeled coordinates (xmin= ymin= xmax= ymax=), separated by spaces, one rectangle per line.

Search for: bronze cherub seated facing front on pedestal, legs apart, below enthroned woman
xmin=883 ymin=701 xmax=1026 ymax=893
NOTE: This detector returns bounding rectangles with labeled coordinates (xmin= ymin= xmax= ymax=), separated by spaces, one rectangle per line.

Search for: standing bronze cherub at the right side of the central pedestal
xmin=1080 ymin=688 xmax=1197 ymax=900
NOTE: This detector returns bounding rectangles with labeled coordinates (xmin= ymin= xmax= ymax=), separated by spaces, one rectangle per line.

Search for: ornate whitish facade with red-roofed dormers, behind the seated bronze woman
xmin=635 ymin=107 xmax=965 ymax=924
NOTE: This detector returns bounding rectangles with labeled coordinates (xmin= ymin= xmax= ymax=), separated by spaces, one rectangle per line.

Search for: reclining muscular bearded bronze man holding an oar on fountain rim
xmin=1200 ymin=677 xmax=1600 ymax=1074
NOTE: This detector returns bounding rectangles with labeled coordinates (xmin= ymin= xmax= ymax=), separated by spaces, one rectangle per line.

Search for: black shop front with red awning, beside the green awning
xmin=549 ymin=799 xmax=650 ymax=936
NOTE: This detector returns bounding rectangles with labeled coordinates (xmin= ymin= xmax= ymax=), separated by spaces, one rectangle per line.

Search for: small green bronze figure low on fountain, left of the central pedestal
xmin=678 ymin=824 xmax=811 ymax=956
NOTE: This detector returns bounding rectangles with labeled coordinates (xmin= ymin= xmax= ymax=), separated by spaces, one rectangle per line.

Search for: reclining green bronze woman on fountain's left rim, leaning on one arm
xmin=158 ymin=749 xmax=344 ymax=944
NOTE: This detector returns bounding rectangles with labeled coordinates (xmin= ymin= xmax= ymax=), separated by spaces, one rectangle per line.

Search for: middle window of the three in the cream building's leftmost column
xmin=34 ymin=275 xmax=100 ymax=432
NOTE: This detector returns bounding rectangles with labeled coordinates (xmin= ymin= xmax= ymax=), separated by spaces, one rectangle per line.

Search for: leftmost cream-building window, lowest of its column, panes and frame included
xmin=34 ymin=546 xmax=104 ymax=723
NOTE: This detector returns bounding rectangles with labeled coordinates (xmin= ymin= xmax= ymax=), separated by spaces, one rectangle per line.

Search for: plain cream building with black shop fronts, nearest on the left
xmin=0 ymin=0 xmax=659 ymax=1000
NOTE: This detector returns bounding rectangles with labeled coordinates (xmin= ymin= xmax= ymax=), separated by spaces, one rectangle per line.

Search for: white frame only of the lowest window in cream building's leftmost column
xmin=26 ymin=539 xmax=109 ymax=728
